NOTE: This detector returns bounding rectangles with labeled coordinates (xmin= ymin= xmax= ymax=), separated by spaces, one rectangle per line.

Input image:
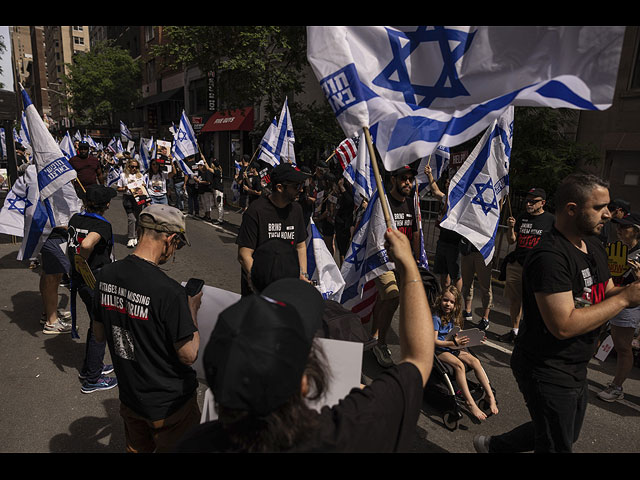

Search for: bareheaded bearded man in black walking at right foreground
xmin=473 ymin=174 xmax=640 ymax=453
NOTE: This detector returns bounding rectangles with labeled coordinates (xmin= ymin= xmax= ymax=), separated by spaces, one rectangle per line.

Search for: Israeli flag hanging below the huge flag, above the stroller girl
xmin=440 ymin=107 xmax=513 ymax=265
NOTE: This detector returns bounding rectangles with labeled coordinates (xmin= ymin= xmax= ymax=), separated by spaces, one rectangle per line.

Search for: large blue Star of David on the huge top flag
xmin=373 ymin=26 xmax=476 ymax=109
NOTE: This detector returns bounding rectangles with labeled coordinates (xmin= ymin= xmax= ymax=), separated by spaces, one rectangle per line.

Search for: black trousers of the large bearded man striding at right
xmin=489 ymin=347 xmax=588 ymax=453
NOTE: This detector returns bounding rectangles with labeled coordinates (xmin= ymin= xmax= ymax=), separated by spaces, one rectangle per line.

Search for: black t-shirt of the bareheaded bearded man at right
xmin=511 ymin=227 xmax=611 ymax=387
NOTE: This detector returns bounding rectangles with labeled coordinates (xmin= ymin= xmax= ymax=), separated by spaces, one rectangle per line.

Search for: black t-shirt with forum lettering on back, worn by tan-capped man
xmin=93 ymin=255 xmax=198 ymax=421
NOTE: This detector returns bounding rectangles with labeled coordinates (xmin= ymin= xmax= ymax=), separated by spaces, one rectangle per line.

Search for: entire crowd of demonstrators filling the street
xmin=6 ymin=136 xmax=640 ymax=452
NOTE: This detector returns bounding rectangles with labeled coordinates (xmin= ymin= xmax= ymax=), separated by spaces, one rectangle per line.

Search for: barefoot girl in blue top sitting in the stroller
xmin=427 ymin=285 xmax=498 ymax=423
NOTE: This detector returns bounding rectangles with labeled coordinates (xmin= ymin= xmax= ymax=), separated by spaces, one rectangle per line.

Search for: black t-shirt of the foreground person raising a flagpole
xmin=177 ymin=362 xmax=423 ymax=453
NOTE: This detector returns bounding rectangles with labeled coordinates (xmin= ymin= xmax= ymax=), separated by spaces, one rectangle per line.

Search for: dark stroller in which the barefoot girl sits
xmin=419 ymin=268 xmax=495 ymax=431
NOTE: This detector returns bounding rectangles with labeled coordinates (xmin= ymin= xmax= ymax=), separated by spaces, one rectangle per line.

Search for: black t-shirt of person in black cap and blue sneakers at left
xmin=67 ymin=213 xmax=113 ymax=281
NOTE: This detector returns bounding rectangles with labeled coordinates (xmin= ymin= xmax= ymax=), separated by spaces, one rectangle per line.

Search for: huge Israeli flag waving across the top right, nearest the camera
xmin=307 ymin=26 xmax=625 ymax=170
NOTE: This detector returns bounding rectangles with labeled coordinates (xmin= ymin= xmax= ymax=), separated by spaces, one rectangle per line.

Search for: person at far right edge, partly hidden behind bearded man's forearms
xmin=598 ymin=212 xmax=640 ymax=402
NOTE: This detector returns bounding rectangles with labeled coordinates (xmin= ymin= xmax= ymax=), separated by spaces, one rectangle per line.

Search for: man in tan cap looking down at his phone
xmin=93 ymin=204 xmax=202 ymax=453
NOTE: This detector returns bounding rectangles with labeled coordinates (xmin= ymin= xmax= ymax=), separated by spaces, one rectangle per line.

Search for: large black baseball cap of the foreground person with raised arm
xmin=203 ymin=279 xmax=324 ymax=416
